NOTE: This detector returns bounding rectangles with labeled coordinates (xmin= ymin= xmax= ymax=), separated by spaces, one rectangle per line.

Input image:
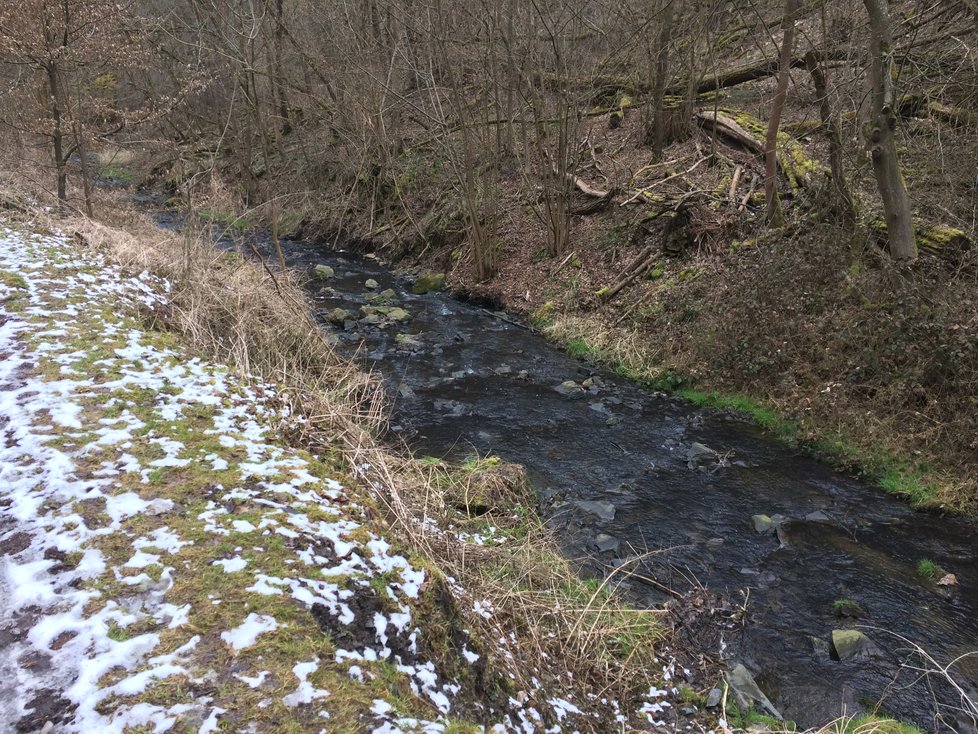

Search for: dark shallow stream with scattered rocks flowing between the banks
xmin=149 ymin=208 xmax=978 ymax=732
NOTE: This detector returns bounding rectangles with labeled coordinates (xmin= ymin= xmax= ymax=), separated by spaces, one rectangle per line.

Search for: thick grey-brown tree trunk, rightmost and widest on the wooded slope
xmin=863 ymin=0 xmax=917 ymax=260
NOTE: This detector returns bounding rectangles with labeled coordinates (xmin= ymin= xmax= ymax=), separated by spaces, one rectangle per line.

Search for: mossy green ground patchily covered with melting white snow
xmin=0 ymin=221 xmax=670 ymax=732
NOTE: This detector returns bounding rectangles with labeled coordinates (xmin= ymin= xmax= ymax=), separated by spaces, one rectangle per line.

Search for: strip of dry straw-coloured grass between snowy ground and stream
xmin=0 ymin=185 xmax=662 ymax=731
